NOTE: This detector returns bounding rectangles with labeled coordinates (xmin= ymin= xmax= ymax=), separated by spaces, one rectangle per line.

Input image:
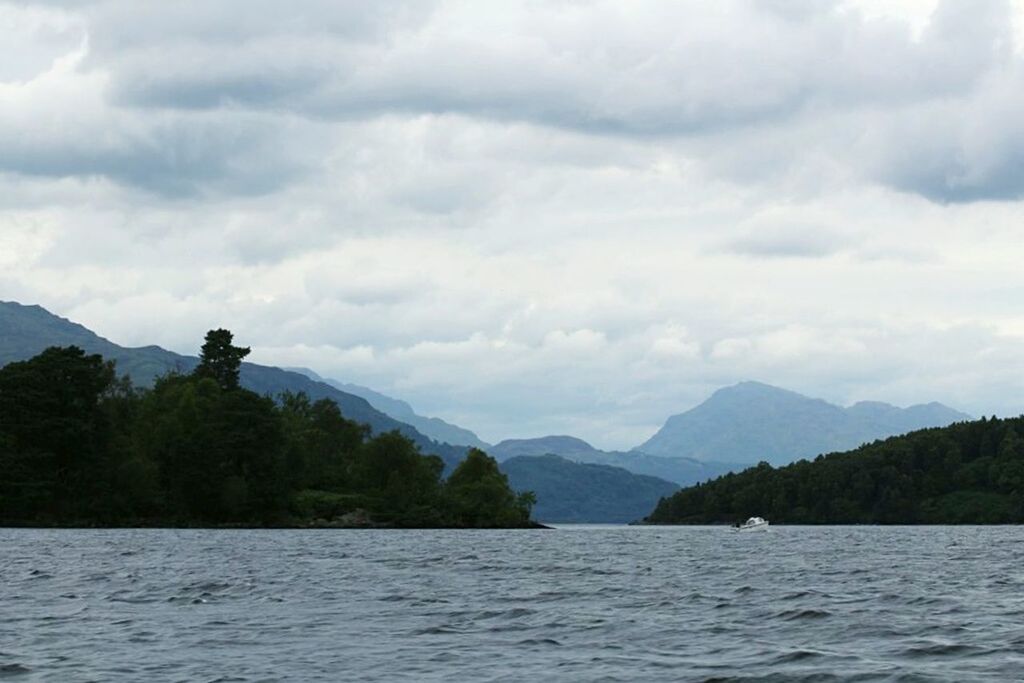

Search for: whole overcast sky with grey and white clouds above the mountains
xmin=0 ymin=0 xmax=1024 ymax=447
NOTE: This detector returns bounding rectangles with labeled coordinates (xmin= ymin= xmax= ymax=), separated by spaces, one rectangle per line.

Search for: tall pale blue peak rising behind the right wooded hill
xmin=635 ymin=382 xmax=971 ymax=465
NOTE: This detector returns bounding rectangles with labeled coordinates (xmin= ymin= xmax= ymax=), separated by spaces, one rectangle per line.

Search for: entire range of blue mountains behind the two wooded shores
xmin=0 ymin=302 xmax=970 ymax=521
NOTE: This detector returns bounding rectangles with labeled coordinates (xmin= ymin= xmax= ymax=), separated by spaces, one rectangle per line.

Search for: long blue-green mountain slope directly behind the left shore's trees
xmin=0 ymin=301 xmax=465 ymax=468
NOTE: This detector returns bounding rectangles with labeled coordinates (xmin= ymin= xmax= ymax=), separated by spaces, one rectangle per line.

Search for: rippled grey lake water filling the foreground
xmin=0 ymin=526 xmax=1024 ymax=681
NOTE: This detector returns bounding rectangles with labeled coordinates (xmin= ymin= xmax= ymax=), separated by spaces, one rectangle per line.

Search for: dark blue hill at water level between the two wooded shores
xmin=501 ymin=456 xmax=679 ymax=523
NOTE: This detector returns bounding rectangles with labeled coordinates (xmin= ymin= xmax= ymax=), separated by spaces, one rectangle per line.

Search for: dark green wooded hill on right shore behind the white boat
xmin=647 ymin=418 xmax=1024 ymax=524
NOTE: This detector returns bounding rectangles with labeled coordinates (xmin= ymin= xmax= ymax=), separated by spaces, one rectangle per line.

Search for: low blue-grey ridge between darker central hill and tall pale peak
xmin=487 ymin=436 xmax=742 ymax=486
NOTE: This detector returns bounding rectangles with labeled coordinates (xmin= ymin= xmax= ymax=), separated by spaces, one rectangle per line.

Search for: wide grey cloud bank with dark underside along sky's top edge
xmin=74 ymin=0 xmax=1007 ymax=135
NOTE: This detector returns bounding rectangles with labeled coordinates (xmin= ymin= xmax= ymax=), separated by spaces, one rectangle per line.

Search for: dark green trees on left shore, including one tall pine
xmin=0 ymin=330 xmax=535 ymax=527
